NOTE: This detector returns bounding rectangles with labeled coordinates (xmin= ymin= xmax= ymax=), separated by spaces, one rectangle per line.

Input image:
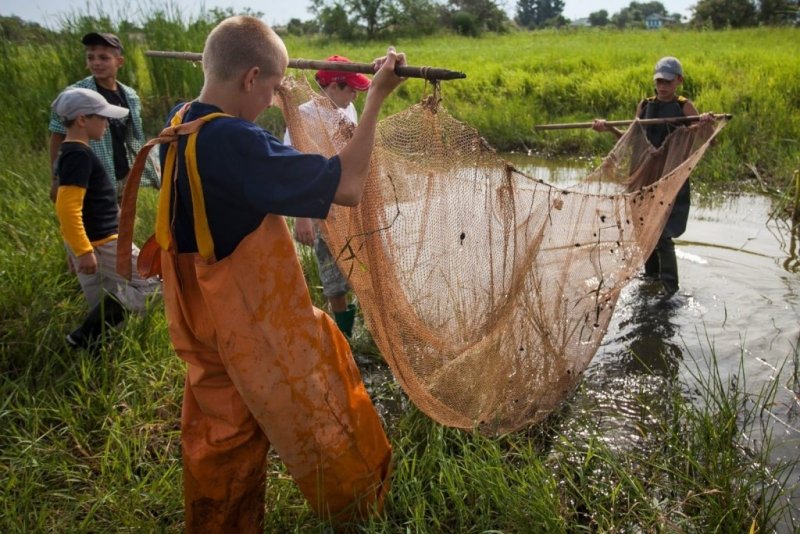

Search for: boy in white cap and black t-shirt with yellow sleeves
xmin=52 ymin=88 xmax=160 ymax=347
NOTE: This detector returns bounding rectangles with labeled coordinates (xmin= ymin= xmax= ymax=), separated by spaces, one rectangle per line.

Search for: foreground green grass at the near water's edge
xmin=0 ymin=138 xmax=796 ymax=533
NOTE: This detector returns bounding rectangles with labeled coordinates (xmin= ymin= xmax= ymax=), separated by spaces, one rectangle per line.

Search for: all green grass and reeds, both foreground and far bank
xmin=0 ymin=11 xmax=800 ymax=533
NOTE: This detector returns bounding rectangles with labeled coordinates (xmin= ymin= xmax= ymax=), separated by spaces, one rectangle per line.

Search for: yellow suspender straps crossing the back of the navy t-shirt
xmin=156 ymin=110 xmax=230 ymax=259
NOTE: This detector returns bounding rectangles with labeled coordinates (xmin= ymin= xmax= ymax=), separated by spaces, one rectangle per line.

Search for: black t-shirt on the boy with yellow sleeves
xmin=56 ymin=141 xmax=119 ymax=241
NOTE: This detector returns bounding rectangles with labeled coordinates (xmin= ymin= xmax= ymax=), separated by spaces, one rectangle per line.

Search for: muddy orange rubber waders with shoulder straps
xmin=118 ymin=105 xmax=391 ymax=532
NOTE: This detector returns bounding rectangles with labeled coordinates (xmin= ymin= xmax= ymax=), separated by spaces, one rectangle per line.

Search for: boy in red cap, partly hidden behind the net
xmin=283 ymin=56 xmax=370 ymax=339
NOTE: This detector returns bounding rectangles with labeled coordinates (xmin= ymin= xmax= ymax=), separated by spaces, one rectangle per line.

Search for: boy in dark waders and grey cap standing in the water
xmin=592 ymin=56 xmax=714 ymax=297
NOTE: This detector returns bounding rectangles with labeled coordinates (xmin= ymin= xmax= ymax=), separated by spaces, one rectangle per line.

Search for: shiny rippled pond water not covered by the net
xmin=508 ymin=155 xmax=800 ymax=531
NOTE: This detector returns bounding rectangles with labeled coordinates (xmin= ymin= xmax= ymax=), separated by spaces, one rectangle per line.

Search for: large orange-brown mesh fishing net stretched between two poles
xmin=279 ymin=77 xmax=725 ymax=433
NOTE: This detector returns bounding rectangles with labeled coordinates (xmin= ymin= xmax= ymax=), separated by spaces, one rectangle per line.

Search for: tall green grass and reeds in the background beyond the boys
xmin=0 ymin=22 xmax=800 ymax=189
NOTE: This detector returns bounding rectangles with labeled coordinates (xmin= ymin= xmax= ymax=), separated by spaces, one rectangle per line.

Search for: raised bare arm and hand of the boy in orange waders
xmin=333 ymin=47 xmax=405 ymax=206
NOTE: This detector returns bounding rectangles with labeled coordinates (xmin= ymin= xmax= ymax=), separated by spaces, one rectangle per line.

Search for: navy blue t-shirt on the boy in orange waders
xmin=161 ymin=102 xmax=341 ymax=260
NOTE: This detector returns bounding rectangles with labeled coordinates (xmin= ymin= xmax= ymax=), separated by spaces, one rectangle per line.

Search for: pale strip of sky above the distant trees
xmin=0 ymin=0 xmax=697 ymax=27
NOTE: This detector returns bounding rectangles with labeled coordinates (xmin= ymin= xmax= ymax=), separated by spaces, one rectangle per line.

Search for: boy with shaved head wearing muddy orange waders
xmin=156 ymin=16 xmax=405 ymax=533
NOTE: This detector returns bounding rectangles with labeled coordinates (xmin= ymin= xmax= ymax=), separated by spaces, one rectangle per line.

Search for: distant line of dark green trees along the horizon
xmin=0 ymin=0 xmax=800 ymax=42
